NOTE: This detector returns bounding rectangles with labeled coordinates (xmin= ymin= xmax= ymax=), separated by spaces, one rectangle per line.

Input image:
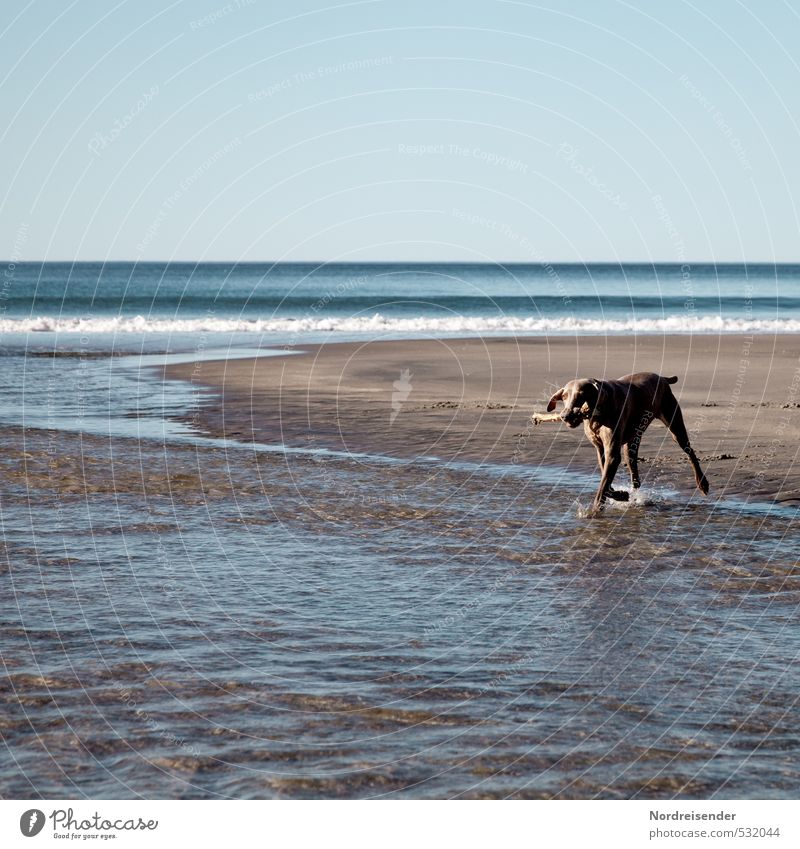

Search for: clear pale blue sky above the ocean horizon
xmin=0 ymin=0 xmax=800 ymax=263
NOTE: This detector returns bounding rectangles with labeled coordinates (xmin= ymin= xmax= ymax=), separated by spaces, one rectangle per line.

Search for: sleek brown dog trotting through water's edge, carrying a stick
xmin=547 ymin=372 xmax=708 ymax=507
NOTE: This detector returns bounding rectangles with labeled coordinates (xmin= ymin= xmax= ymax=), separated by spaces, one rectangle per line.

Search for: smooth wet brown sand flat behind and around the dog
xmin=166 ymin=335 xmax=800 ymax=504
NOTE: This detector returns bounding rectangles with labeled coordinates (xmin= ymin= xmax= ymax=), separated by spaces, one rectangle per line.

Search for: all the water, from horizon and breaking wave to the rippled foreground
xmin=0 ymin=263 xmax=800 ymax=799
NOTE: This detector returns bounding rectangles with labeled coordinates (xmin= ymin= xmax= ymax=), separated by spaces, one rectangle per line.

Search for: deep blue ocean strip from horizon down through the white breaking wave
xmin=0 ymin=263 xmax=800 ymax=345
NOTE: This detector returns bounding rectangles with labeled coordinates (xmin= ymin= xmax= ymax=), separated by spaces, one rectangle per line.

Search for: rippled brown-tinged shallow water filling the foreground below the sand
xmin=0 ymin=399 xmax=800 ymax=798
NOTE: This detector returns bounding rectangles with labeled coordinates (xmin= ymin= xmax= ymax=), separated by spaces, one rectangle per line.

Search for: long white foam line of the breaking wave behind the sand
xmin=0 ymin=315 xmax=800 ymax=335
